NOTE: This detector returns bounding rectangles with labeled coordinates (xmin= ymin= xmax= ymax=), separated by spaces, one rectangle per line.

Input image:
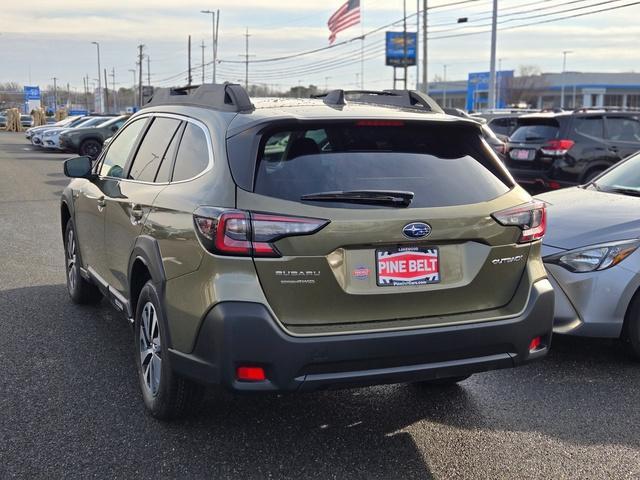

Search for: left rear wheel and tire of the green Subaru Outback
xmin=134 ymin=281 xmax=204 ymax=420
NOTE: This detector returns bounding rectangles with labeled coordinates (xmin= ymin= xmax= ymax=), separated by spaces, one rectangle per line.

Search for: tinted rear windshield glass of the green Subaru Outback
xmin=254 ymin=121 xmax=511 ymax=208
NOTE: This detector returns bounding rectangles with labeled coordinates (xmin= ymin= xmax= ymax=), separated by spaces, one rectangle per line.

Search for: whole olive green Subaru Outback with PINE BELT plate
xmin=61 ymin=84 xmax=553 ymax=418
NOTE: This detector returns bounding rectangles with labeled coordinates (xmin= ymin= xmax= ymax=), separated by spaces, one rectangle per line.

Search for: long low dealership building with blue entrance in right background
xmin=429 ymin=70 xmax=640 ymax=111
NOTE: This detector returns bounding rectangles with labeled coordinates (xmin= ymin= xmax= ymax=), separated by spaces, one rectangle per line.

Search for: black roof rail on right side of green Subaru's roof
xmin=312 ymin=89 xmax=444 ymax=113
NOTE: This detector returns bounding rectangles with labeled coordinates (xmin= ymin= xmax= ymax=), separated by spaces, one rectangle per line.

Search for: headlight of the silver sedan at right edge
xmin=544 ymin=239 xmax=640 ymax=273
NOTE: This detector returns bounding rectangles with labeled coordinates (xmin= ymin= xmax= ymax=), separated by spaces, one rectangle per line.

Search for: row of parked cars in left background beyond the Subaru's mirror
xmin=25 ymin=115 xmax=128 ymax=158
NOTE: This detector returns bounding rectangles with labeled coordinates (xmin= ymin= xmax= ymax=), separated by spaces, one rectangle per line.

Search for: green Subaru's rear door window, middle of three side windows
xmin=128 ymin=117 xmax=180 ymax=182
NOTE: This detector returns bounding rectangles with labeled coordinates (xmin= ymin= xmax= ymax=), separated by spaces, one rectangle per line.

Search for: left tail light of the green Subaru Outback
xmin=193 ymin=207 xmax=329 ymax=257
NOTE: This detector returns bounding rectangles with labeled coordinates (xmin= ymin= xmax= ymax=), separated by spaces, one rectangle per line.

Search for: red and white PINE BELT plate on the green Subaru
xmin=376 ymin=247 xmax=440 ymax=287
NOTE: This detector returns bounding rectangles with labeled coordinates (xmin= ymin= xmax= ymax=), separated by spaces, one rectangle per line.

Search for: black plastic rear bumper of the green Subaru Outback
xmin=169 ymin=280 xmax=554 ymax=391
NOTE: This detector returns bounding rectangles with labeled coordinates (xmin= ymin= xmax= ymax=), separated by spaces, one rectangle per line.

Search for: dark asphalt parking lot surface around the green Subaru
xmin=0 ymin=132 xmax=640 ymax=479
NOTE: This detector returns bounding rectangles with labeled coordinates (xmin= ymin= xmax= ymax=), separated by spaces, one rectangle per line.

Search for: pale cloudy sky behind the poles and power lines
xmin=0 ymin=0 xmax=640 ymax=90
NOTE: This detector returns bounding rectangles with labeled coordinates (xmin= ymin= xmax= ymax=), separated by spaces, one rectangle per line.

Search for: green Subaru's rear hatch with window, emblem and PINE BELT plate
xmin=232 ymin=121 xmax=529 ymax=329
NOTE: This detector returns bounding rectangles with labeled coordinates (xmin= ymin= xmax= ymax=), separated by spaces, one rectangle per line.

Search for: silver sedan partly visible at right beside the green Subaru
xmin=538 ymin=154 xmax=640 ymax=356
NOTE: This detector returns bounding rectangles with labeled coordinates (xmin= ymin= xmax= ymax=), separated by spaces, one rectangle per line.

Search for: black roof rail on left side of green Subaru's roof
xmin=144 ymin=82 xmax=255 ymax=112
